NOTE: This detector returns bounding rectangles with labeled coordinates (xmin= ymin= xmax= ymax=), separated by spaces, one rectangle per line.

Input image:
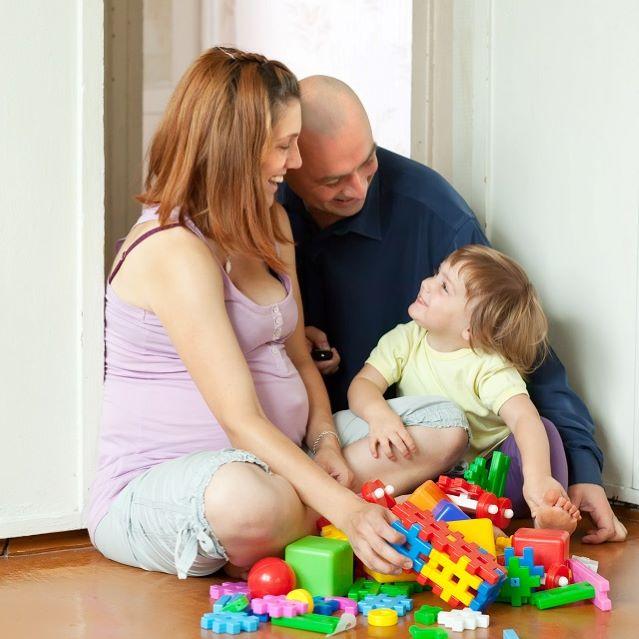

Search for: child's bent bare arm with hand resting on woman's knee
xmin=348 ymin=364 xmax=417 ymax=461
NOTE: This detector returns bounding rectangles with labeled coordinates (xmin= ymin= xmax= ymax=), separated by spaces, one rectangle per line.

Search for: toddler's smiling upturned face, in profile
xmin=408 ymin=262 xmax=470 ymax=348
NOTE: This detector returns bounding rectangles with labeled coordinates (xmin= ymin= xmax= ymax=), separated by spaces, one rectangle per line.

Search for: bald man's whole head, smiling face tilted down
xmin=286 ymin=75 xmax=377 ymax=228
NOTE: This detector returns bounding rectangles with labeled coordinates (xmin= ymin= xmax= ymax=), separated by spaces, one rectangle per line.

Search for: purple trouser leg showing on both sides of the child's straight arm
xmin=500 ymin=417 xmax=568 ymax=517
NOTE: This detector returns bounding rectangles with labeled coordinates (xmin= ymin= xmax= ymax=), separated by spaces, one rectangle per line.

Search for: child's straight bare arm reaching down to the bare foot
xmin=499 ymin=394 xmax=578 ymax=517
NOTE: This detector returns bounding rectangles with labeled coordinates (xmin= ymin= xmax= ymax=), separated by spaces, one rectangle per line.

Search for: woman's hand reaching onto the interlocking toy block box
xmin=335 ymin=500 xmax=413 ymax=575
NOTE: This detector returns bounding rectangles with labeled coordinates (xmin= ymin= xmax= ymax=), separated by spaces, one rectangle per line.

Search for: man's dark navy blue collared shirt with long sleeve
xmin=279 ymin=148 xmax=603 ymax=484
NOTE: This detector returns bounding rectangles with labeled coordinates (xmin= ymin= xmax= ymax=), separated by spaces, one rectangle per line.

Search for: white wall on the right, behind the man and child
xmin=444 ymin=0 xmax=639 ymax=503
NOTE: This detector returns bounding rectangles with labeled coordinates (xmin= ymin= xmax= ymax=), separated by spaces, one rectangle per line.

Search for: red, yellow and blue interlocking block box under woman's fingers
xmin=392 ymin=500 xmax=506 ymax=610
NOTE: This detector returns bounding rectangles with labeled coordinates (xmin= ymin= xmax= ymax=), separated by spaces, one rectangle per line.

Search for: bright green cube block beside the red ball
xmin=284 ymin=535 xmax=353 ymax=597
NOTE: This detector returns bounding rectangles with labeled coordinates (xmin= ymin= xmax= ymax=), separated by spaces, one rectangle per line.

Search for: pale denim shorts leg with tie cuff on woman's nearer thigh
xmin=93 ymin=448 xmax=269 ymax=579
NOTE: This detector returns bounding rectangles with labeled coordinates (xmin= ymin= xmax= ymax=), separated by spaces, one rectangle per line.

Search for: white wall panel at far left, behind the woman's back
xmin=0 ymin=0 xmax=104 ymax=538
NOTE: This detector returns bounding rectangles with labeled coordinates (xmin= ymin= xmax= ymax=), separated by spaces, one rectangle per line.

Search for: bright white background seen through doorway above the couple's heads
xmin=202 ymin=0 xmax=412 ymax=155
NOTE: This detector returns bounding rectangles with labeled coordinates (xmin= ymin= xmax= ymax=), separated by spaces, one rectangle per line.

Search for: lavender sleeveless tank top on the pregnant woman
xmin=87 ymin=208 xmax=309 ymax=536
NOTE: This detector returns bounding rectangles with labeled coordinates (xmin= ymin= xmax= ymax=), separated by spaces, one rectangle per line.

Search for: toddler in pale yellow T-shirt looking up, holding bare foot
xmin=348 ymin=245 xmax=580 ymax=532
